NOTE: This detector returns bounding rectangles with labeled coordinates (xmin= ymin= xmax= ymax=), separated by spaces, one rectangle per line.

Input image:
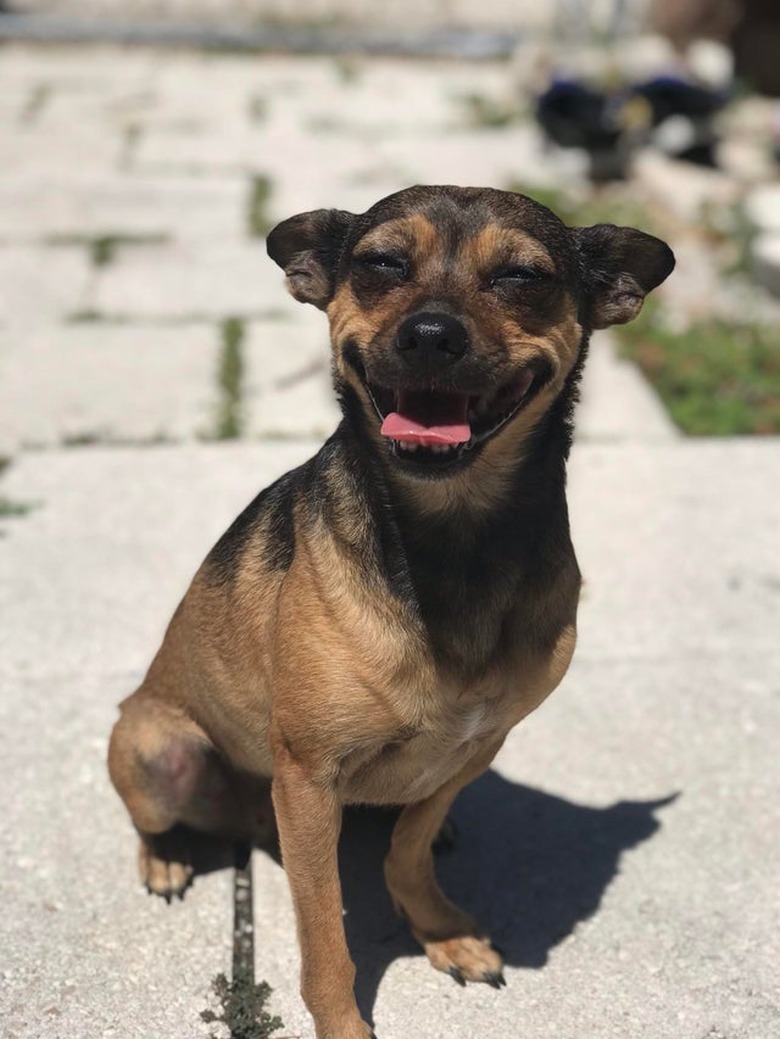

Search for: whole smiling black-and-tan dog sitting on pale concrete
xmin=109 ymin=187 xmax=674 ymax=1039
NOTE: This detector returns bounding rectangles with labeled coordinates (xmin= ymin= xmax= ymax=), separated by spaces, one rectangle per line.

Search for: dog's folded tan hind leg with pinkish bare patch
xmin=108 ymin=691 xmax=262 ymax=899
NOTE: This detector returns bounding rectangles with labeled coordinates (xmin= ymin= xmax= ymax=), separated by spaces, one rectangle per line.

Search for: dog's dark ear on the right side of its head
xmin=572 ymin=223 xmax=674 ymax=328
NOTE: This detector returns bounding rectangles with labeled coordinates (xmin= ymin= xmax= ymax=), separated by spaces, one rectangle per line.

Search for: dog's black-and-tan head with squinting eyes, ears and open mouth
xmin=268 ymin=187 xmax=674 ymax=479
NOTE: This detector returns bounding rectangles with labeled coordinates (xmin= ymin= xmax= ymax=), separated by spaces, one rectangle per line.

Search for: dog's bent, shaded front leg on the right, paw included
xmin=384 ymin=744 xmax=504 ymax=988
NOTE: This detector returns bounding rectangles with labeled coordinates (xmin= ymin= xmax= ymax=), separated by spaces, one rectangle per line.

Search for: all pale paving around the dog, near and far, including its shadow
xmin=0 ymin=47 xmax=780 ymax=1039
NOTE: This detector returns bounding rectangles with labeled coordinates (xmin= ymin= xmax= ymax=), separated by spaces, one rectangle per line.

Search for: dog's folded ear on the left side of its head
xmin=266 ymin=209 xmax=355 ymax=310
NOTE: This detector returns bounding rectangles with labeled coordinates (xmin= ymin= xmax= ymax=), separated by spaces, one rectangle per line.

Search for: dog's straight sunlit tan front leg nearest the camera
xmin=272 ymin=753 xmax=372 ymax=1039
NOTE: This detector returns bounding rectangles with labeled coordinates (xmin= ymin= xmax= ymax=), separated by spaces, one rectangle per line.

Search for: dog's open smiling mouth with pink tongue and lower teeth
xmin=365 ymin=366 xmax=546 ymax=468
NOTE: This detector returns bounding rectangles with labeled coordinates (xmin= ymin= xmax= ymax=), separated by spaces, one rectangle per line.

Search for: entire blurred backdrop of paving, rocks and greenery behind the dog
xmin=0 ymin=0 xmax=780 ymax=457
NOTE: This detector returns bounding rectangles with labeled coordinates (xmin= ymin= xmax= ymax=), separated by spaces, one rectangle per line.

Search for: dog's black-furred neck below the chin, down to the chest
xmin=315 ymin=382 xmax=575 ymax=673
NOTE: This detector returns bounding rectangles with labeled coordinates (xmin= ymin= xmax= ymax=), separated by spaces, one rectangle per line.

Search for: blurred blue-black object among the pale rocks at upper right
xmin=536 ymin=76 xmax=728 ymax=182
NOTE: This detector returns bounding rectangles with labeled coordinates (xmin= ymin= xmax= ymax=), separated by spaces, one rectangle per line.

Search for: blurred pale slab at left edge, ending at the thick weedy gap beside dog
xmin=0 ymin=323 xmax=219 ymax=450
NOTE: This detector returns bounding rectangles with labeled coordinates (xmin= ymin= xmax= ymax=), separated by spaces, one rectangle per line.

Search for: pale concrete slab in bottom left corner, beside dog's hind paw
xmin=0 ymin=669 xmax=233 ymax=1039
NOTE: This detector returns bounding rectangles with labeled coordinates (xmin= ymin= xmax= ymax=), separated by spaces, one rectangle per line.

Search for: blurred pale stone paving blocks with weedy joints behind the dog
xmin=0 ymin=46 xmax=672 ymax=455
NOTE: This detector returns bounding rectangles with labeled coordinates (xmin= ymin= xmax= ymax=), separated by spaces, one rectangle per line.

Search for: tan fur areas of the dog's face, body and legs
xmin=109 ymin=189 xmax=673 ymax=1039
